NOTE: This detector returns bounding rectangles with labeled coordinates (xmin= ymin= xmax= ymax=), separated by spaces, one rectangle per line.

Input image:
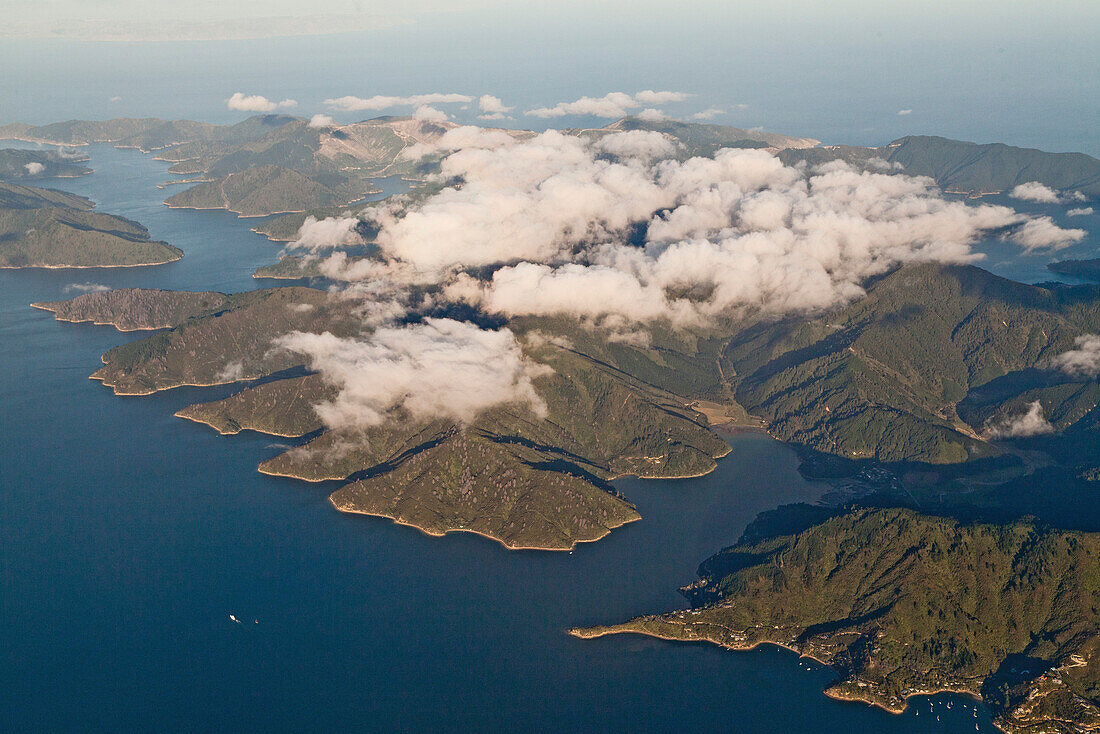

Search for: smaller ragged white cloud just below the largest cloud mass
xmin=277 ymin=319 xmax=546 ymax=430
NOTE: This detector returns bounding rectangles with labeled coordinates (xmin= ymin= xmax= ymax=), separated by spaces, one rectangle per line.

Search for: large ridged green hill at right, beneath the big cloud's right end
xmin=724 ymin=264 xmax=1100 ymax=463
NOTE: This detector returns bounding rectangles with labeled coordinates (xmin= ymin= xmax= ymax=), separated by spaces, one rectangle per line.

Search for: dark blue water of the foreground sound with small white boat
xmin=0 ymin=146 xmax=1007 ymax=733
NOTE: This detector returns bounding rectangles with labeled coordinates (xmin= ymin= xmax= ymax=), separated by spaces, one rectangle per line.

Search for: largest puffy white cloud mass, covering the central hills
xmin=323 ymin=128 xmax=1025 ymax=324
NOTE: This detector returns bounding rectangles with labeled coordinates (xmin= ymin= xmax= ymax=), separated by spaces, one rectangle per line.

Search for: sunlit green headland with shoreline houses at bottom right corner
xmin=572 ymin=507 xmax=1100 ymax=734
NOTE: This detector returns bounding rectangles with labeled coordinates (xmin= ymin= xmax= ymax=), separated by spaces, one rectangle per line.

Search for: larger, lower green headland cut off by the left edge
xmin=0 ymin=183 xmax=183 ymax=267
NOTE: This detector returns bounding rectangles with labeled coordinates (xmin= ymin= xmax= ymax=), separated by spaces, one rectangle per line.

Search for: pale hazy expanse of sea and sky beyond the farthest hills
xmin=0 ymin=0 xmax=1100 ymax=155
